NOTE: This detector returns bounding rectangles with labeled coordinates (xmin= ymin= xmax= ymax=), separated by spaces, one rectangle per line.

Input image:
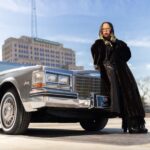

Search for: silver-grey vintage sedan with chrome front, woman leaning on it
xmin=0 ymin=63 xmax=113 ymax=134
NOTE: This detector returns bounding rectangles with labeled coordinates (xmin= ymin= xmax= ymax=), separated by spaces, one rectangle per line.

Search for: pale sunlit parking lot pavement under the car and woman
xmin=0 ymin=117 xmax=150 ymax=150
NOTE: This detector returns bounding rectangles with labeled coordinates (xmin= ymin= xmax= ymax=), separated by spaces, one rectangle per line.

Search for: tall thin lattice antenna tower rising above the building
xmin=31 ymin=0 xmax=37 ymax=38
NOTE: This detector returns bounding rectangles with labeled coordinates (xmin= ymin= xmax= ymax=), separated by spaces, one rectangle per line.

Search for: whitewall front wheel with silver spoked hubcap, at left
xmin=0 ymin=89 xmax=30 ymax=134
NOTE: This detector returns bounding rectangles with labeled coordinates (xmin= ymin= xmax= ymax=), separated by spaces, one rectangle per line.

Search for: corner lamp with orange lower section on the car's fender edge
xmin=32 ymin=71 xmax=45 ymax=88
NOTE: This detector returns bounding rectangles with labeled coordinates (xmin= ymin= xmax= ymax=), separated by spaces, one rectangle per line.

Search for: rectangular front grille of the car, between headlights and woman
xmin=74 ymin=75 xmax=101 ymax=98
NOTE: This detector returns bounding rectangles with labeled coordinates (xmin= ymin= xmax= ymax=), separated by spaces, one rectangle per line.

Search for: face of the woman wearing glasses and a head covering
xmin=101 ymin=23 xmax=111 ymax=38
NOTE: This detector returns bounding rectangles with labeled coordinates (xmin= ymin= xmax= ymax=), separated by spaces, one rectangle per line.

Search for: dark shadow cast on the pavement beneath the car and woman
xmin=0 ymin=128 xmax=150 ymax=146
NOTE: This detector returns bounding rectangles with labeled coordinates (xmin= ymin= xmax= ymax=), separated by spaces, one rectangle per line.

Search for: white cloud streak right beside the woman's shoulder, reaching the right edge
xmin=127 ymin=37 xmax=150 ymax=48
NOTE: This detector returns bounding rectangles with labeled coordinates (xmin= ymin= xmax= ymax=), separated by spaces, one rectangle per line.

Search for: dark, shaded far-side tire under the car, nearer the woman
xmin=80 ymin=118 xmax=108 ymax=131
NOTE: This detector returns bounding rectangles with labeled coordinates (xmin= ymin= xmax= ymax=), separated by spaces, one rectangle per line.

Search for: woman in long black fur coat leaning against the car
xmin=91 ymin=22 xmax=148 ymax=133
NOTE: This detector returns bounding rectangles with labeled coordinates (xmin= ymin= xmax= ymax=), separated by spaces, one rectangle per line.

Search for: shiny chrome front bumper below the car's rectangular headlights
xmin=23 ymin=96 xmax=91 ymax=112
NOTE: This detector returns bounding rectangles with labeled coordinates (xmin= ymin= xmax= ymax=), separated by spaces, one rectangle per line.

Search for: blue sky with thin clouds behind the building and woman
xmin=0 ymin=0 xmax=150 ymax=78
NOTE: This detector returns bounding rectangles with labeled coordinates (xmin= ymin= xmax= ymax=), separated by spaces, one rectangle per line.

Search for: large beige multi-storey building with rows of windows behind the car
xmin=2 ymin=36 xmax=83 ymax=70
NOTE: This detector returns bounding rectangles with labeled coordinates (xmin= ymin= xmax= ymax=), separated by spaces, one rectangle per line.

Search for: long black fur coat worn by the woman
xmin=91 ymin=39 xmax=145 ymax=117
